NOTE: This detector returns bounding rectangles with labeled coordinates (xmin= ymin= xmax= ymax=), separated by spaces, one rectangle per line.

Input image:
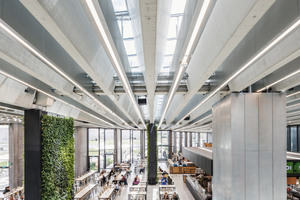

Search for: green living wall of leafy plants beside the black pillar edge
xmin=41 ymin=115 xmax=75 ymax=200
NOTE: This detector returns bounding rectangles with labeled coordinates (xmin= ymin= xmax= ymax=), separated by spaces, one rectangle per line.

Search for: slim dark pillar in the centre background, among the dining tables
xmin=148 ymin=124 xmax=157 ymax=185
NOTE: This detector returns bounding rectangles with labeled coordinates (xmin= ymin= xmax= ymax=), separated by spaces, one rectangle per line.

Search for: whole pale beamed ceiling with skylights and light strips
xmin=0 ymin=0 xmax=300 ymax=132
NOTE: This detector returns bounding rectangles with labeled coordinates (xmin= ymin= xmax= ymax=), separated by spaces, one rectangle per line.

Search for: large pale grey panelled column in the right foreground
xmin=213 ymin=93 xmax=286 ymax=200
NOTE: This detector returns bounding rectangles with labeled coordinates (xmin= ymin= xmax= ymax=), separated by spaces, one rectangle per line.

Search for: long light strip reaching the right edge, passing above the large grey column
xmin=176 ymin=19 xmax=300 ymax=125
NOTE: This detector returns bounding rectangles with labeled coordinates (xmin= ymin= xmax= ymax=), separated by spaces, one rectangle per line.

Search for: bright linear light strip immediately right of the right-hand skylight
xmin=157 ymin=0 xmax=211 ymax=129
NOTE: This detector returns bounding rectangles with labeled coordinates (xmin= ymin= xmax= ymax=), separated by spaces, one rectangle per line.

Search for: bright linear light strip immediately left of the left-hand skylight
xmin=85 ymin=0 xmax=147 ymax=129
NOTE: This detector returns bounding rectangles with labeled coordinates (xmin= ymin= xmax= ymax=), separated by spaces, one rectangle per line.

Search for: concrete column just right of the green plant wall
xmin=75 ymin=127 xmax=88 ymax=177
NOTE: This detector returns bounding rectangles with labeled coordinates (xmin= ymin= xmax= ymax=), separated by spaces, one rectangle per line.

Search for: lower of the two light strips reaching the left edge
xmin=0 ymin=70 xmax=115 ymax=127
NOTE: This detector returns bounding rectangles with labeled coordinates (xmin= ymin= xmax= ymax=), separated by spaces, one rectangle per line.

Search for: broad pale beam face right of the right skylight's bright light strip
xmin=168 ymin=0 xmax=275 ymax=127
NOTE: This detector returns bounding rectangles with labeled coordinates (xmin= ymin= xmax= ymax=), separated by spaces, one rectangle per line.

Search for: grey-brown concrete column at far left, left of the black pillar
xmin=9 ymin=123 xmax=24 ymax=189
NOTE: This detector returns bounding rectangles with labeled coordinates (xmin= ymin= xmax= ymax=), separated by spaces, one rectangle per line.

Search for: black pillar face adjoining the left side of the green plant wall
xmin=24 ymin=109 xmax=42 ymax=200
